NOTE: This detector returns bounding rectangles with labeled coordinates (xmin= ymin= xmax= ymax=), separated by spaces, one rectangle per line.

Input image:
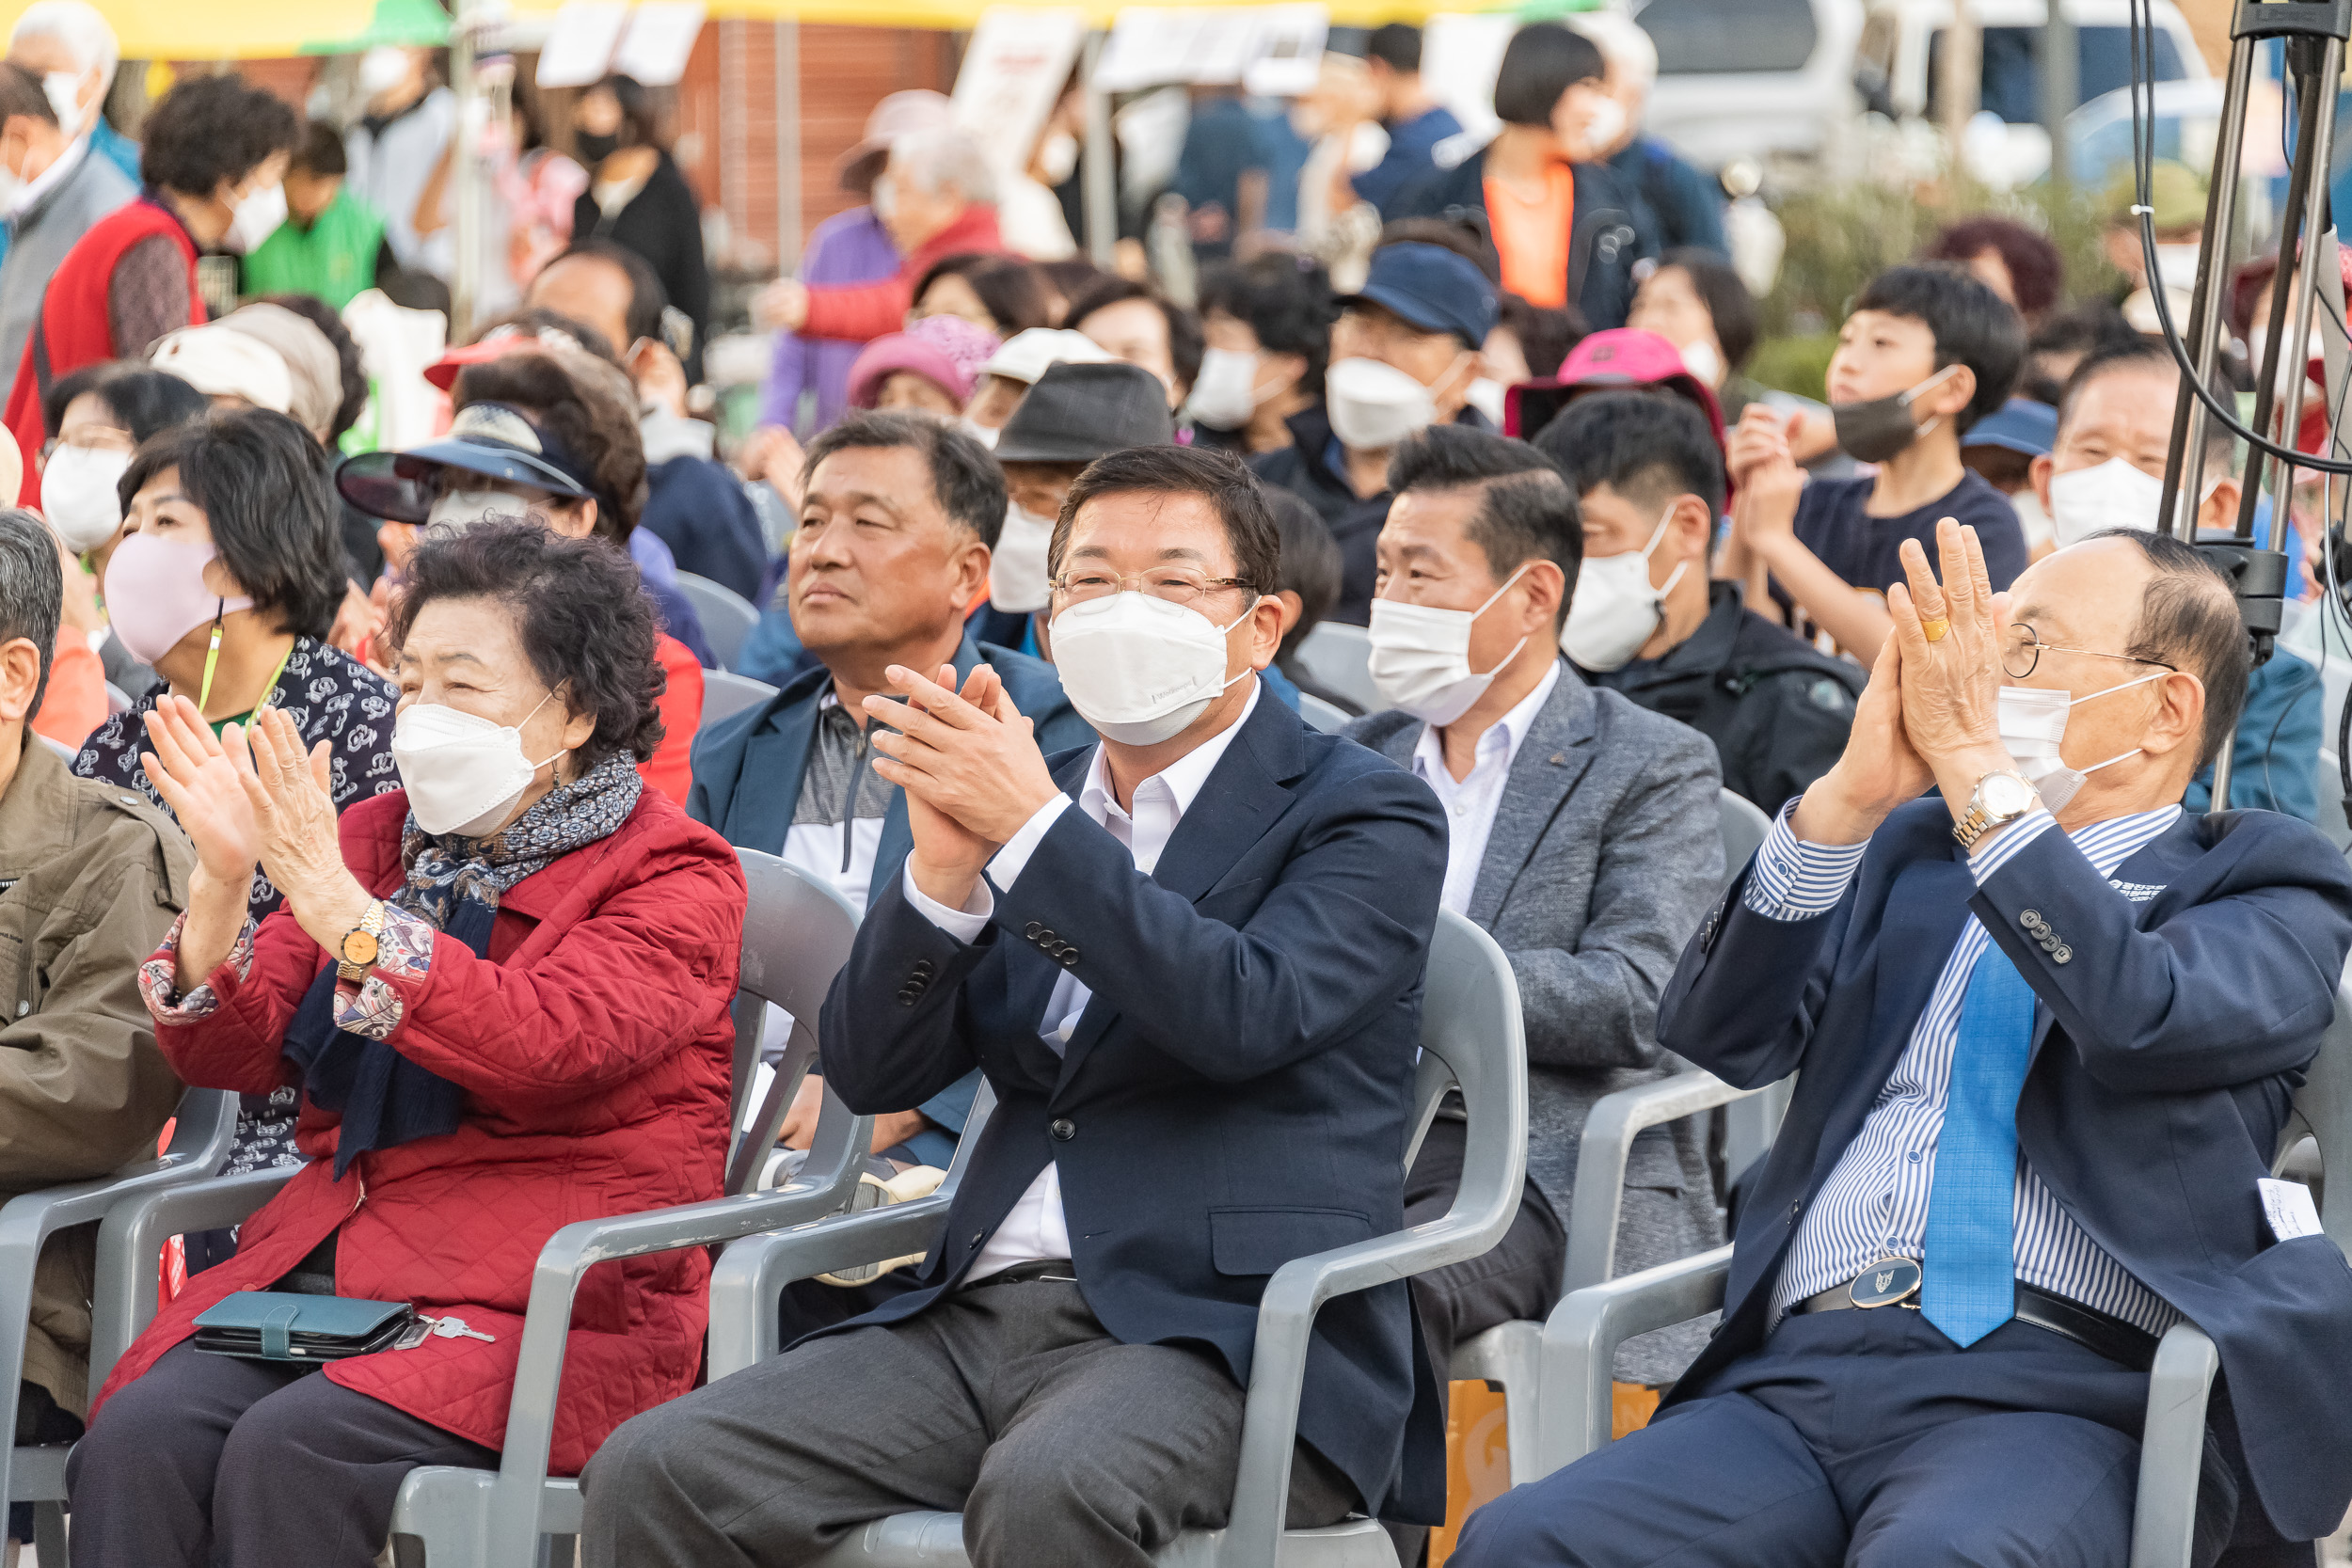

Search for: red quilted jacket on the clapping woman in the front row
xmin=92 ymin=790 xmax=743 ymax=1474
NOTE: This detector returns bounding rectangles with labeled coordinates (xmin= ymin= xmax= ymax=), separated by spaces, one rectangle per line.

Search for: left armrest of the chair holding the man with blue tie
xmin=1536 ymin=1246 xmax=1731 ymax=1477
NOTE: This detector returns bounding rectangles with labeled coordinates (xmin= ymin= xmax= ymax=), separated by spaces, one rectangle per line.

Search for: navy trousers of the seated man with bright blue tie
xmin=1454 ymin=1307 xmax=2239 ymax=1568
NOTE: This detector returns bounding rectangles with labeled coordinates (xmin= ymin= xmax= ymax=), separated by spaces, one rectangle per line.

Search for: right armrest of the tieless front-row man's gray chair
xmin=1226 ymin=1203 xmax=1524 ymax=1568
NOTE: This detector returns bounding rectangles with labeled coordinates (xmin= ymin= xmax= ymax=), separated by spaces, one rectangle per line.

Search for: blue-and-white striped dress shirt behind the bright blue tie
xmin=1743 ymin=801 xmax=2181 ymax=1333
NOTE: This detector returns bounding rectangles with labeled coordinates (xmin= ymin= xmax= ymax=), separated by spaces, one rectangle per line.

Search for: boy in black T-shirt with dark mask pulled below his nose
xmin=1724 ymin=265 xmax=2026 ymax=665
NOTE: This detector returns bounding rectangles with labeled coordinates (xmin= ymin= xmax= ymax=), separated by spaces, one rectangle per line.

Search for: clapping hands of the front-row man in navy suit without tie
xmin=866 ymin=665 xmax=1058 ymax=910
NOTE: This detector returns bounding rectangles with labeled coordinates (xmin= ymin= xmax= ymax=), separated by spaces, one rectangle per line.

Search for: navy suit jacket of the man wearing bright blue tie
xmin=1659 ymin=797 xmax=2352 ymax=1540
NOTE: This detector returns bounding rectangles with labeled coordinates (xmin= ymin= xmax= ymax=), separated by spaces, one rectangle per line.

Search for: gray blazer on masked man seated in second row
xmin=1348 ymin=668 xmax=1724 ymax=1383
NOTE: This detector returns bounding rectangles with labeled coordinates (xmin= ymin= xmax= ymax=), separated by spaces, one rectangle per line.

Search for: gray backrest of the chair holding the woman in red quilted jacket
xmin=727 ymin=848 xmax=859 ymax=1192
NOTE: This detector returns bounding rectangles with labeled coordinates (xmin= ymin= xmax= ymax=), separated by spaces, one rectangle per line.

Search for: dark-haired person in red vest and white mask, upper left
xmin=5 ymin=75 xmax=299 ymax=505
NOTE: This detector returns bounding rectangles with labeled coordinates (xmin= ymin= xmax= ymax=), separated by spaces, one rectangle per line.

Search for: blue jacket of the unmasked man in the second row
xmin=687 ymin=632 xmax=1094 ymax=1164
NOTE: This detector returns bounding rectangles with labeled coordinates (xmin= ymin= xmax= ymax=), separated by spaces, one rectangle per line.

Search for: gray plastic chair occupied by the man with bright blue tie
xmin=1538 ymin=985 xmax=2352 ymax=1568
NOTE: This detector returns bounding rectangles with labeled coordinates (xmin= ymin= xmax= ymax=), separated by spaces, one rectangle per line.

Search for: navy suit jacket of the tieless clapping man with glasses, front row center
xmin=818 ymin=698 xmax=1447 ymax=1524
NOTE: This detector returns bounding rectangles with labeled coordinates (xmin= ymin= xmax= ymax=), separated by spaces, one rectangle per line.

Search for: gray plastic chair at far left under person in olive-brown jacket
xmin=0 ymin=1088 xmax=238 ymax=1563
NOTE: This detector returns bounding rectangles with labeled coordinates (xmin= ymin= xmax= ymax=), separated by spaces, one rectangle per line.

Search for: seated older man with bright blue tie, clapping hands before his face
xmin=1456 ymin=519 xmax=2352 ymax=1568
